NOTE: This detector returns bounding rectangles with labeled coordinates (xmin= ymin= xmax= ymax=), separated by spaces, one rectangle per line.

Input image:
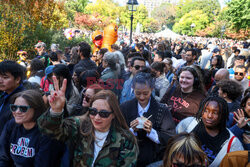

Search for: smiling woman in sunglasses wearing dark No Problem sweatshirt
xmin=0 ymin=90 xmax=65 ymax=167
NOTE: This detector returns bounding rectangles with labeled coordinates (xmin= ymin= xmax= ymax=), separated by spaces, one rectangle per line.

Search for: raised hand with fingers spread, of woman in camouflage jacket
xmin=48 ymin=76 xmax=67 ymax=112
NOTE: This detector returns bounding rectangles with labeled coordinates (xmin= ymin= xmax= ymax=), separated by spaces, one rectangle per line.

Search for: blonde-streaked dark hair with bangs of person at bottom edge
xmin=163 ymin=133 xmax=208 ymax=167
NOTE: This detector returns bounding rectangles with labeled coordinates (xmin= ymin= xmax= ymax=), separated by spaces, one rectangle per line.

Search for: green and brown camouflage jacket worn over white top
xmin=38 ymin=111 xmax=138 ymax=167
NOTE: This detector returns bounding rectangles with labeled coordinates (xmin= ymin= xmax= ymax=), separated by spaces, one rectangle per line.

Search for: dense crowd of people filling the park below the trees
xmin=0 ymin=35 xmax=250 ymax=167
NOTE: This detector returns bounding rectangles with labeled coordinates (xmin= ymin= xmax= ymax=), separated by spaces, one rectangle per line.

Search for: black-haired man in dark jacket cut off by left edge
xmin=0 ymin=60 xmax=24 ymax=134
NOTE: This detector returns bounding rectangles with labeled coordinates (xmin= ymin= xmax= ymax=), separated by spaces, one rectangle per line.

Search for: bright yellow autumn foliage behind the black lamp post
xmin=81 ymin=0 xmax=158 ymax=32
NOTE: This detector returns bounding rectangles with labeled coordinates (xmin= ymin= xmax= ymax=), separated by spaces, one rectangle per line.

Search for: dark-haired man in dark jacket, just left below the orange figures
xmin=74 ymin=42 xmax=97 ymax=70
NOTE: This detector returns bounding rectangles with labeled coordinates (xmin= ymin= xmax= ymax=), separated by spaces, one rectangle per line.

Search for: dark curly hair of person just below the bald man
xmin=217 ymin=79 xmax=243 ymax=101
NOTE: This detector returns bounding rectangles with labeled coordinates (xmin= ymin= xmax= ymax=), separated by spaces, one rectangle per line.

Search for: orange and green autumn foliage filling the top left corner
xmin=0 ymin=0 xmax=68 ymax=59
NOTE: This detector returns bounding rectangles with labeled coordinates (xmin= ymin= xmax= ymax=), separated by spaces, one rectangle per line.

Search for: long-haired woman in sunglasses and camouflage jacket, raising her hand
xmin=38 ymin=77 xmax=138 ymax=167
